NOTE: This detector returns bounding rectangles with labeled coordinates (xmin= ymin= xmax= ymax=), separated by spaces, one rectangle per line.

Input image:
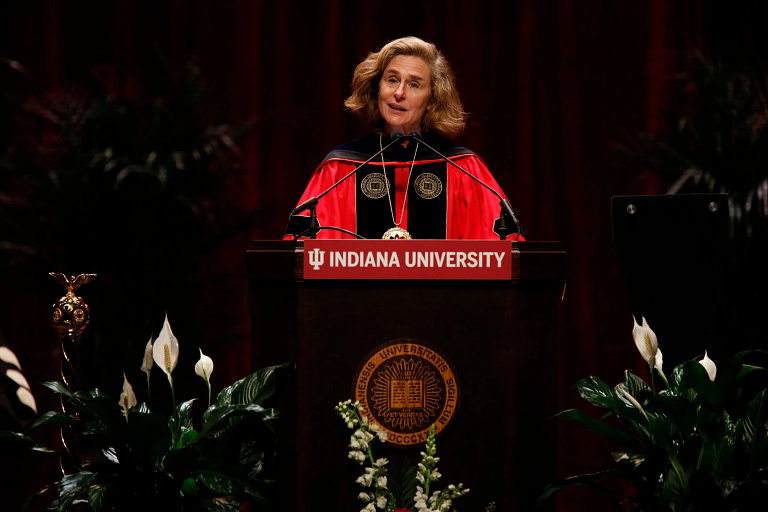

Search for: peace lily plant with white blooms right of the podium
xmin=539 ymin=318 xmax=768 ymax=512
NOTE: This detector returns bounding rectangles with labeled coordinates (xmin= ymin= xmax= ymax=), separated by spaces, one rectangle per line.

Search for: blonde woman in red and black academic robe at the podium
xmin=286 ymin=37 xmax=514 ymax=240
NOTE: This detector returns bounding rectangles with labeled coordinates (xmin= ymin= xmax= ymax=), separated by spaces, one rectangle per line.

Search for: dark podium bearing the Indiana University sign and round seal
xmin=246 ymin=241 xmax=566 ymax=512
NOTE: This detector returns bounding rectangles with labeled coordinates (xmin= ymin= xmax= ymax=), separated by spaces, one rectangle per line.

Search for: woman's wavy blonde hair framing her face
xmin=344 ymin=37 xmax=466 ymax=137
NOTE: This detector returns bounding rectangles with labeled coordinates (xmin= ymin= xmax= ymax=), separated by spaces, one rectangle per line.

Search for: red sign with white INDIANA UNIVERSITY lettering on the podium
xmin=304 ymin=240 xmax=512 ymax=280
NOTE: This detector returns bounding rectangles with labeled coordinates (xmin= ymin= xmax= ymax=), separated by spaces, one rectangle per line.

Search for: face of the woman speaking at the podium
xmin=379 ymin=55 xmax=432 ymax=135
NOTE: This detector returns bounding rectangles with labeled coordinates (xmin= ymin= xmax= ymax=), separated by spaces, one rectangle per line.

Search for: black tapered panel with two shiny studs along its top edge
xmin=611 ymin=194 xmax=728 ymax=368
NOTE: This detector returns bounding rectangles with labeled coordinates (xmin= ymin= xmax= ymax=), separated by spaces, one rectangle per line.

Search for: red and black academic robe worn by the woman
xmin=285 ymin=131 xmax=522 ymax=240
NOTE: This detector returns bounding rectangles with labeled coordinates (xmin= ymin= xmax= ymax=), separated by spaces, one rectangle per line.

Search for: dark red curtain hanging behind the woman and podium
xmin=0 ymin=0 xmax=764 ymax=510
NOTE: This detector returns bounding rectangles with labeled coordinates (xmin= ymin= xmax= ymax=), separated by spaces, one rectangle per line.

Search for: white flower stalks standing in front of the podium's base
xmin=335 ymin=400 xmax=472 ymax=512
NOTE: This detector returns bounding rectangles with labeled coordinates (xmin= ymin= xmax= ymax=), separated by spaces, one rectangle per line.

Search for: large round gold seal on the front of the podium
xmin=354 ymin=339 xmax=459 ymax=448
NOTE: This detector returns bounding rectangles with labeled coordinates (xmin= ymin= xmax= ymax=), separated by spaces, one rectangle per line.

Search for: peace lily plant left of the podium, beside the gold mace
xmin=0 ymin=316 xmax=288 ymax=512
